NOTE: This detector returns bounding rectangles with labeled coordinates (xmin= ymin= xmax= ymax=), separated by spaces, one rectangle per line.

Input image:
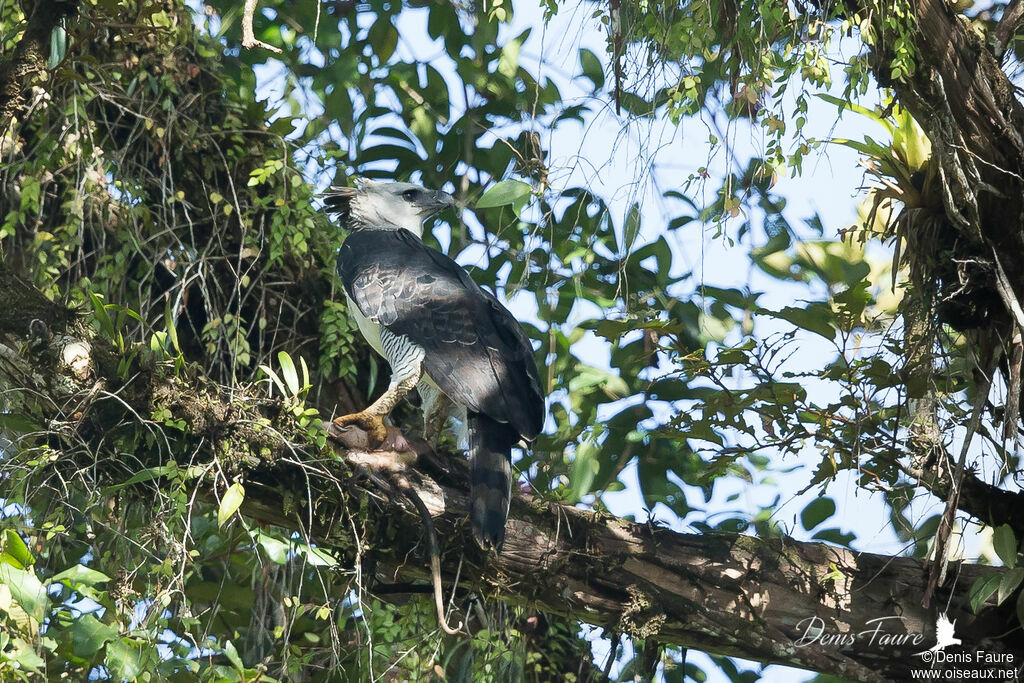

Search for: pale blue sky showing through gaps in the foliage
xmin=234 ymin=0 xmax=991 ymax=681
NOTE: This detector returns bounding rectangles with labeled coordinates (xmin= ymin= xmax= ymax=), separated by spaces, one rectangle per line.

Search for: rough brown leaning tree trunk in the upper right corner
xmin=874 ymin=0 xmax=1024 ymax=266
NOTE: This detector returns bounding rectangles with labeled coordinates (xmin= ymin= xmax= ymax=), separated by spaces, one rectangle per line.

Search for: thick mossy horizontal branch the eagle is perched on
xmin=0 ymin=272 xmax=1024 ymax=680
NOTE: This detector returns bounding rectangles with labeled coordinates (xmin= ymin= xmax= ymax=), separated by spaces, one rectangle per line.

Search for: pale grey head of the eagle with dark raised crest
xmin=324 ymin=178 xmax=455 ymax=237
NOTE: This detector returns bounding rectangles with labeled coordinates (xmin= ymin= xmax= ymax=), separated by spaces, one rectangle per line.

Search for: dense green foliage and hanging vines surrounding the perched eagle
xmin=0 ymin=0 xmax=1024 ymax=681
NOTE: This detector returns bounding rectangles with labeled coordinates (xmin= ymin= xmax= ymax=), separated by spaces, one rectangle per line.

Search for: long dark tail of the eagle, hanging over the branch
xmin=468 ymin=413 xmax=519 ymax=552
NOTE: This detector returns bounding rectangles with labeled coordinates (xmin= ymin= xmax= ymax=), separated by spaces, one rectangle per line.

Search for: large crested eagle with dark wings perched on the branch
xmin=325 ymin=180 xmax=544 ymax=552
